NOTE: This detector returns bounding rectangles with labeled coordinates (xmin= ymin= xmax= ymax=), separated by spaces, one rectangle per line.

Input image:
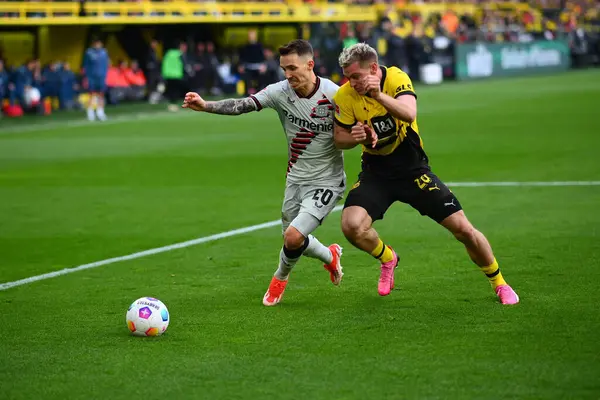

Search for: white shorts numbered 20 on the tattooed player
xmin=281 ymin=181 xmax=346 ymax=236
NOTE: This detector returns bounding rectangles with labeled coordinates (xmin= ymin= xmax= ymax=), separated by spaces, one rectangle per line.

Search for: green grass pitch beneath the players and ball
xmin=0 ymin=71 xmax=600 ymax=400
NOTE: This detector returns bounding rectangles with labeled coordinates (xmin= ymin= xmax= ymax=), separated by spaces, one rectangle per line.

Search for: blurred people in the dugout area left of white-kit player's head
xmin=0 ymin=30 xmax=282 ymax=116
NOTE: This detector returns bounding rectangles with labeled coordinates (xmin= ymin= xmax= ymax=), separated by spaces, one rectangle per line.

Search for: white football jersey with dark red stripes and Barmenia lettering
xmin=250 ymin=77 xmax=346 ymax=185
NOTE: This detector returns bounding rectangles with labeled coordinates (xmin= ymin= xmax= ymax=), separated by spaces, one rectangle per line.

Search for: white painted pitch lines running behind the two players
xmin=0 ymin=181 xmax=600 ymax=291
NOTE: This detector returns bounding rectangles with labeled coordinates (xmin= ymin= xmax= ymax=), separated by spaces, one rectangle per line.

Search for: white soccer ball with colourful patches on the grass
xmin=125 ymin=297 xmax=169 ymax=336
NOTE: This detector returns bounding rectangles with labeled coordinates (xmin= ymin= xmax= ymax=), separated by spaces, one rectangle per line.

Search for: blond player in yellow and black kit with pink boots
xmin=334 ymin=43 xmax=519 ymax=304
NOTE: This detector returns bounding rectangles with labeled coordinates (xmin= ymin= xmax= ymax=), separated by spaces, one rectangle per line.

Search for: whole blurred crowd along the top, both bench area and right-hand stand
xmin=0 ymin=0 xmax=600 ymax=114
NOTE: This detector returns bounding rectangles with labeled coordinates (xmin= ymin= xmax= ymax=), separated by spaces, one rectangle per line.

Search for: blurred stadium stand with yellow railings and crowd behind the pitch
xmin=0 ymin=0 xmax=600 ymax=115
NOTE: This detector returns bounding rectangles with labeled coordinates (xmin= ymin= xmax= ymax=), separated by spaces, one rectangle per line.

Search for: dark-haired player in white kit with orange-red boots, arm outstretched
xmin=182 ymin=40 xmax=346 ymax=306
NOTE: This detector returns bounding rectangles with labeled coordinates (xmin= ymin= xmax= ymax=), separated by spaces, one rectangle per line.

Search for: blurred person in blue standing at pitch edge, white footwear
xmin=83 ymin=39 xmax=109 ymax=121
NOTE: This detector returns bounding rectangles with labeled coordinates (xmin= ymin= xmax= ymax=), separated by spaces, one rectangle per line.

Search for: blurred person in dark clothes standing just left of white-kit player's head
xmin=238 ymin=29 xmax=267 ymax=95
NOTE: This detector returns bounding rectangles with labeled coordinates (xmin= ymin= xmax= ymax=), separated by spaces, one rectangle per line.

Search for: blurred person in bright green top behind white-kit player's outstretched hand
xmin=162 ymin=42 xmax=187 ymax=111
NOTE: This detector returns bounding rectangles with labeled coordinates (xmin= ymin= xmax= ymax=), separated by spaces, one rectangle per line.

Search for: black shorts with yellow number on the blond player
xmin=344 ymin=171 xmax=462 ymax=223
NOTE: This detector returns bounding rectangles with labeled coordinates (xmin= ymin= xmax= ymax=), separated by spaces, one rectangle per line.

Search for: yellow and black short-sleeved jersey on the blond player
xmin=333 ymin=66 xmax=429 ymax=177
